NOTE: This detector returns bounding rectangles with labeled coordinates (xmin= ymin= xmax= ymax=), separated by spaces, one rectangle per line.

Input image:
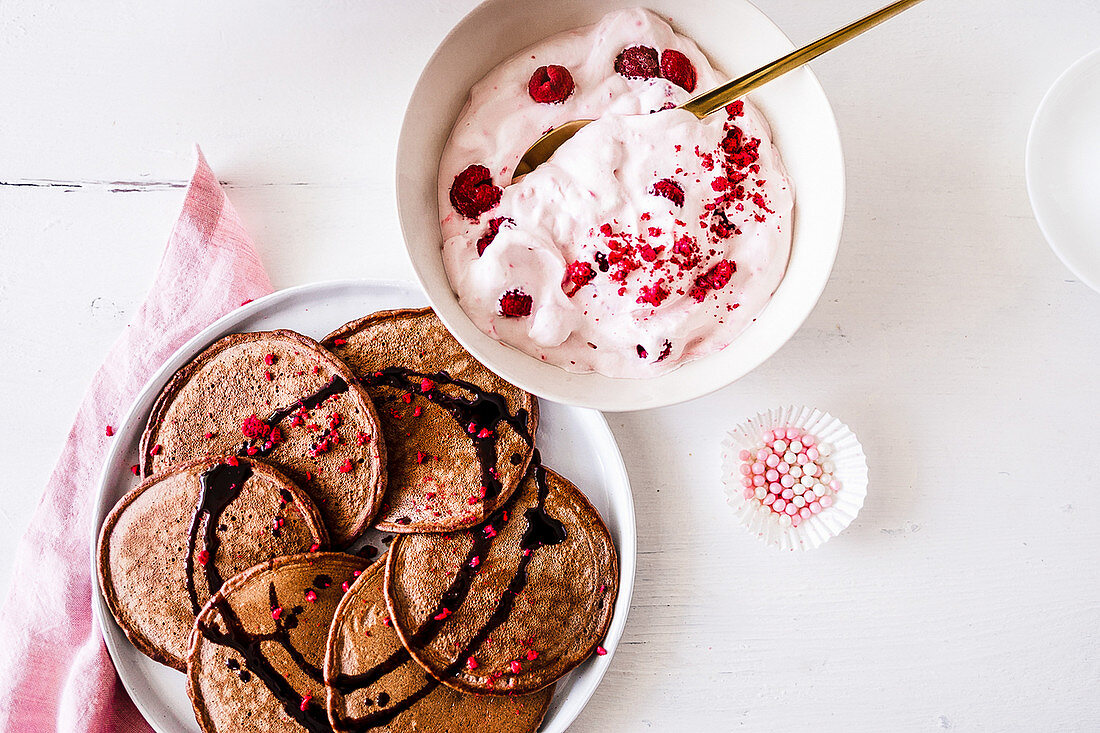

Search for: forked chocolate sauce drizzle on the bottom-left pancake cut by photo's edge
xmin=199 ymin=583 xmax=332 ymax=733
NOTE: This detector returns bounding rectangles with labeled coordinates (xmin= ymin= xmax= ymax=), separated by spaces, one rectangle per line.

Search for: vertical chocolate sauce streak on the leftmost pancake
xmin=184 ymin=462 xmax=252 ymax=615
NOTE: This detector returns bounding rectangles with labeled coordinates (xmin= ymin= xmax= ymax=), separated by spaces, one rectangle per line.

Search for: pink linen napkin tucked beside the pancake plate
xmin=0 ymin=145 xmax=272 ymax=733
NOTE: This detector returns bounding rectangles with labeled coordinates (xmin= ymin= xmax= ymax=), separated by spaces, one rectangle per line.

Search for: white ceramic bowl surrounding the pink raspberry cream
xmin=397 ymin=0 xmax=844 ymax=411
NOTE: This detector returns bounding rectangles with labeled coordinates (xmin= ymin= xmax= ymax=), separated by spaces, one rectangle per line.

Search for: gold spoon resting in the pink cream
xmin=512 ymin=0 xmax=921 ymax=183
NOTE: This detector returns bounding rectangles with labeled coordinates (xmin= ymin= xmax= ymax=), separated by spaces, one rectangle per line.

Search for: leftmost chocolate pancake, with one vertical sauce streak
xmin=98 ymin=456 xmax=328 ymax=670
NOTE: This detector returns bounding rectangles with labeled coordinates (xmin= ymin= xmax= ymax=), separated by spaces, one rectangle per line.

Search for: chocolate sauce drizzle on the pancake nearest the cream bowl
xmin=362 ymin=367 xmax=531 ymax=500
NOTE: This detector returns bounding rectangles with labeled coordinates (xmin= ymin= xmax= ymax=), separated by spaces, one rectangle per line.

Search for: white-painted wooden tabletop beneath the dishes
xmin=0 ymin=0 xmax=1100 ymax=732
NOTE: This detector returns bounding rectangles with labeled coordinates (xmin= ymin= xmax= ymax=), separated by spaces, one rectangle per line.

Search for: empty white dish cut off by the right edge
xmin=1025 ymin=44 xmax=1100 ymax=292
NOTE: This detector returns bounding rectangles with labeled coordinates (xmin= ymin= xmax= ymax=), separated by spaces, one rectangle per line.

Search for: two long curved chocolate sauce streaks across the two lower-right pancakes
xmin=332 ymin=450 xmax=568 ymax=733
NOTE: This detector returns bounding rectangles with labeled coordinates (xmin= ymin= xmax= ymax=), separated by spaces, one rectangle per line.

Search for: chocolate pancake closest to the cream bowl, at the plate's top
xmin=323 ymin=308 xmax=538 ymax=533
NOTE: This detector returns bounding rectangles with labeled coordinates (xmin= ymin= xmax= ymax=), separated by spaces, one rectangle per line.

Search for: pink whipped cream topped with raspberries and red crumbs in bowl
xmin=439 ymin=9 xmax=793 ymax=378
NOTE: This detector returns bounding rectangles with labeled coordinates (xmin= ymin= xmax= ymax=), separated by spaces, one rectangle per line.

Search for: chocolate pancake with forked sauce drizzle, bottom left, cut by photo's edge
xmin=187 ymin=553 xmax=369 ymax=733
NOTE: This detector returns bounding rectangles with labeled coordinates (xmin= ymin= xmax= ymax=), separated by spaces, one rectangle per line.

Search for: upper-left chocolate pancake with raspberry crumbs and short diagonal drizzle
xmin=141 ymin=331 xmax=386 ymax=546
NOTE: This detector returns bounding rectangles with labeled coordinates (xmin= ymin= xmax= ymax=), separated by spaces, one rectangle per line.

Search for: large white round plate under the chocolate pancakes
xmin=91 ymin=281 xmax=637 ymax=733
